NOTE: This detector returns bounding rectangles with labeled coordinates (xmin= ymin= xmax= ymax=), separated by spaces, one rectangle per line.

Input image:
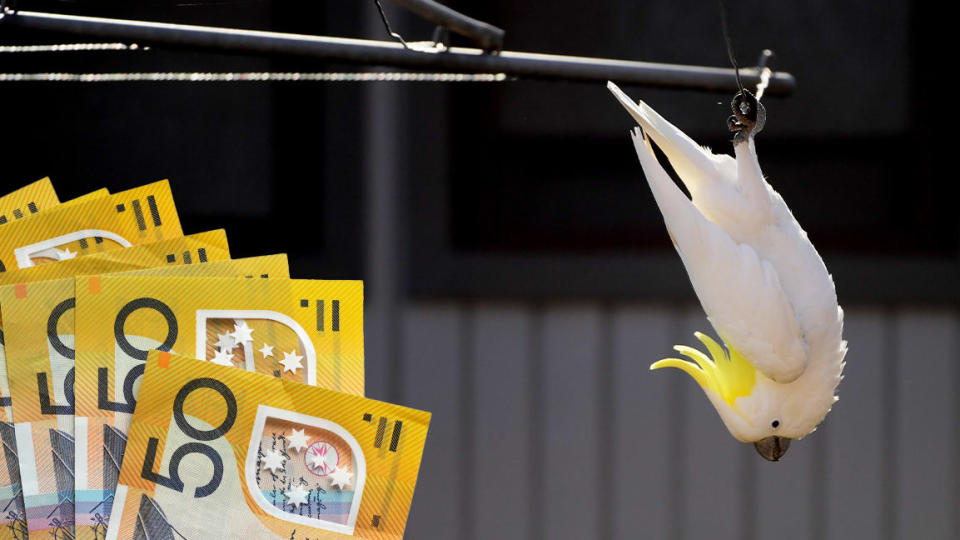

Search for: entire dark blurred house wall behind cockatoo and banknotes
xmin=0 ymin=0 xmax=960 ymax=540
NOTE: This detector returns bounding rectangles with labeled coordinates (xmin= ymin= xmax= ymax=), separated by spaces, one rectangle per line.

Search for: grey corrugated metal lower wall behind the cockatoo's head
xmin=386 ymin=302 xmax=960 ymax=540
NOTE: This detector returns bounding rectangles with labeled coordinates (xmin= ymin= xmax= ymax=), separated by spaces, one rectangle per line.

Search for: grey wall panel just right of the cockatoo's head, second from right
xmin=824 ymin=307 xmax=884 ymax=540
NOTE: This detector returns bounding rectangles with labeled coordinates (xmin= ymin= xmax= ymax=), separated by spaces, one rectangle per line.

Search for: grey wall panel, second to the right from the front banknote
xmin=465 ymin=304 xmax=539 ymax=539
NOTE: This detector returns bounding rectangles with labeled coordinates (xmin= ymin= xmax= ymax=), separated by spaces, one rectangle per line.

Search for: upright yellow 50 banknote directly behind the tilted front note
xmin=77 ymin=276 xmax=363 ymax=537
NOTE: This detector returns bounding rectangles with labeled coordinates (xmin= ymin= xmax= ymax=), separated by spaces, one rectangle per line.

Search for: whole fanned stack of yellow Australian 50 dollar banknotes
xmin=0 ymin=179 xmax=430 ymax=540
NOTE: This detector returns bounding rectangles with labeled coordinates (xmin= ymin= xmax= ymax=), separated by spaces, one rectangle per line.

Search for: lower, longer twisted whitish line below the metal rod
xmin=0 ymin=71 xmax=507 ymax=83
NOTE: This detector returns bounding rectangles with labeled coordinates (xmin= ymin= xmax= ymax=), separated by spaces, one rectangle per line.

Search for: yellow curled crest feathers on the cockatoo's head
xmin=650 ymin=332 xmax=757 ymax=407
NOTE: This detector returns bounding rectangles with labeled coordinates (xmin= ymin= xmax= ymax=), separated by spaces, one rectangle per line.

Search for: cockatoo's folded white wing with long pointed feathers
xmin=632 ymin=128 xmax=807 ymax=383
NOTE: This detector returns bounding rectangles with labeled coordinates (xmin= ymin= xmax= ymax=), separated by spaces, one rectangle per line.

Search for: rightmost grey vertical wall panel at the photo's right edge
xmin=890 ymin=310 xmax=960 ymax=538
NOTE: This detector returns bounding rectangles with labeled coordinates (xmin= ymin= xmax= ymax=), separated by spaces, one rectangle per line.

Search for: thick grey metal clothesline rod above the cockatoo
xmin=0 ymin=9 xmax=796 ymax=96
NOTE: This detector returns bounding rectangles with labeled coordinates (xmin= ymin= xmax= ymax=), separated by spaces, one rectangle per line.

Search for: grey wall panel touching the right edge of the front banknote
xmin=400 ymin=303 xmax=465 ymax=538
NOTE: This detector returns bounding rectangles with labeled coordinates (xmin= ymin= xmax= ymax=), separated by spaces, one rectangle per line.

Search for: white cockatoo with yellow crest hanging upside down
xmin=607 ymin=83 xmax=847 ymax=461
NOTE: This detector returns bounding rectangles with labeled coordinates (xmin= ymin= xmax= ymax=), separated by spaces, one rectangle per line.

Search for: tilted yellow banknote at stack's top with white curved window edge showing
xmin=0 ymin=180 xmax=182 ymax=272
